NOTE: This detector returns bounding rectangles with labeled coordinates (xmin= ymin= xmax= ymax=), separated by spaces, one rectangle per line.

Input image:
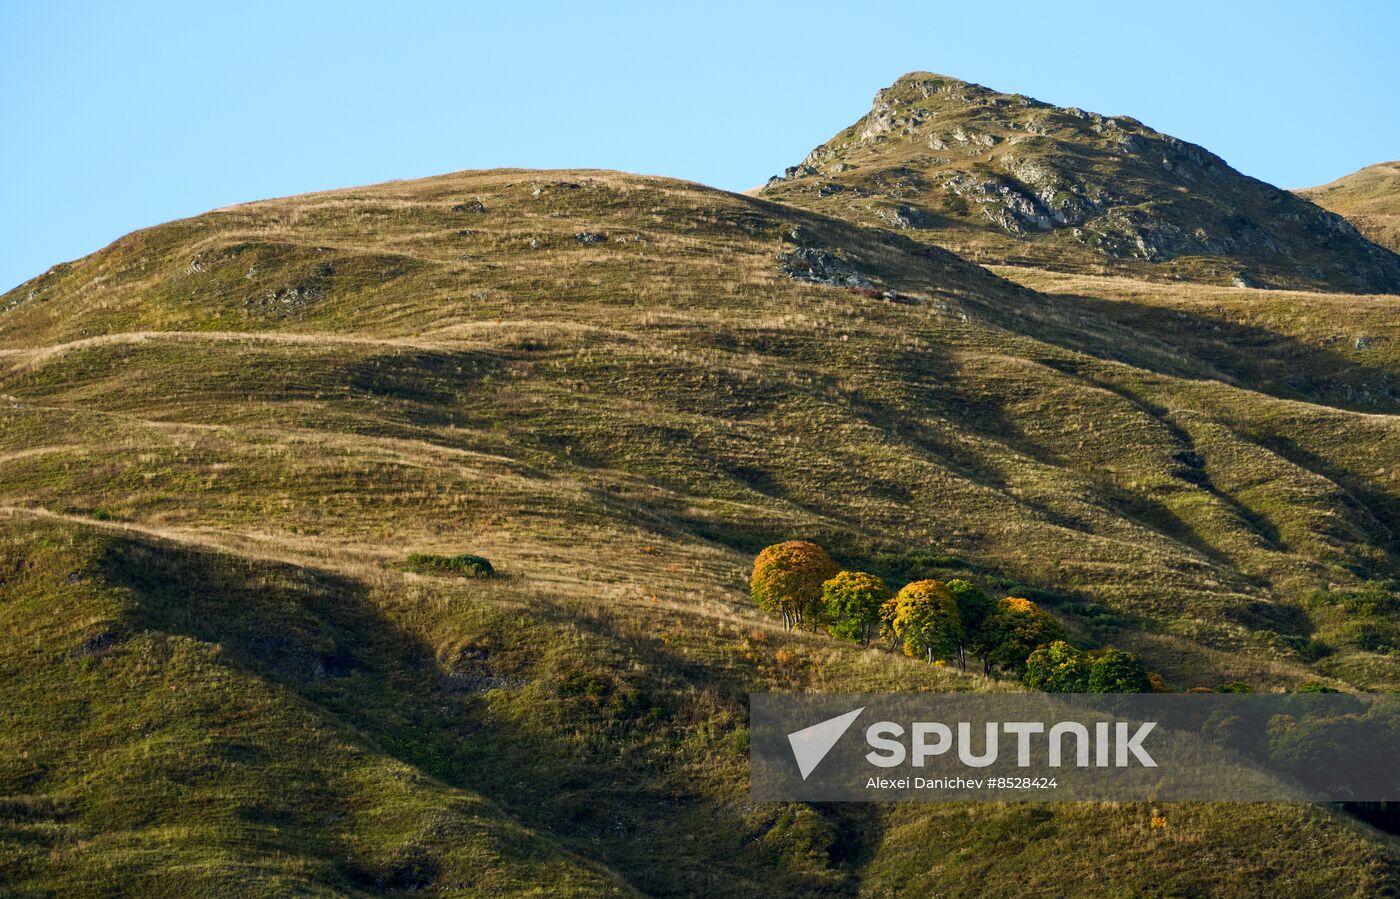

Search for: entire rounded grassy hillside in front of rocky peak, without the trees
xmin=0 ymin=171 xmax=1400 ymax=895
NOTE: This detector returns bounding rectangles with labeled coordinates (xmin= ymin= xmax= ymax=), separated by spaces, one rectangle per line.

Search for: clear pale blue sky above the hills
xmin=0 ymin=0 xmax=1400 ymax=290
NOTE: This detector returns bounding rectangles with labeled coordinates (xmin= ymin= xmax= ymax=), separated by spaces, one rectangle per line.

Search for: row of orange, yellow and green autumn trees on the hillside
xmin=750 ymin=541 xmax=1152 ymax=693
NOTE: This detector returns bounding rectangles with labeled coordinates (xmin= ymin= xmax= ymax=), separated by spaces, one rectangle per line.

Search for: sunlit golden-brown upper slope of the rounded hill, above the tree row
xmin=0 ymin=172 xmax=1397 ymax=682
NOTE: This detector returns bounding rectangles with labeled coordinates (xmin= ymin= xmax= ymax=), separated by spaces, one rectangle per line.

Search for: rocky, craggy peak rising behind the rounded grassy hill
xmin=760 ymin=71 xmax=1400 ymax=293
